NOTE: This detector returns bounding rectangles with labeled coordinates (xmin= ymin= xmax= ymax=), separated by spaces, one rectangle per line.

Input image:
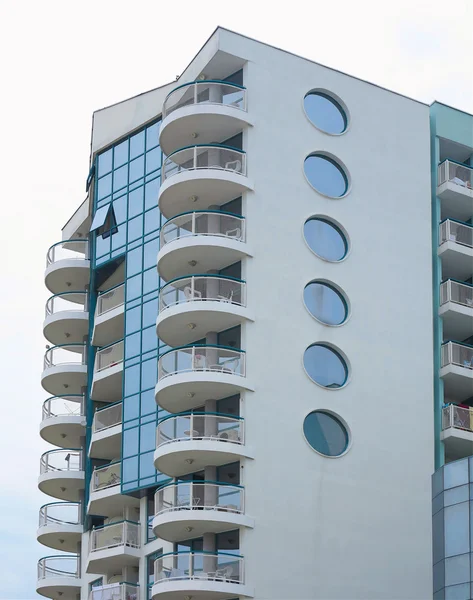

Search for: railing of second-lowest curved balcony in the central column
xmin=154 ymin=481 xmax=244 ymax=515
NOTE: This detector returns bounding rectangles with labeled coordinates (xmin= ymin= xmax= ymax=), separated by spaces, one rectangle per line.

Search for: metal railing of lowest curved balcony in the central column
xmin=154 ymin=552 xmax=244 ymax=585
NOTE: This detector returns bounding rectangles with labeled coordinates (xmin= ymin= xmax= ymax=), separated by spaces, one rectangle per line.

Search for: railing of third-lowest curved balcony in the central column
xmin=156 ymin=412 xmax=245 ymax=447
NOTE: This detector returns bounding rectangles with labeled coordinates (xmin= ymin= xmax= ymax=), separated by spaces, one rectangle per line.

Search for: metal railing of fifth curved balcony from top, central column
xmin=158 ymin=345 xmax=245 ymax=380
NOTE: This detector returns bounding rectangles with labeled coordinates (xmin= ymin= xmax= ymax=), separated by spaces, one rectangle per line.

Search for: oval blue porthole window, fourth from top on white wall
xmin=304 ymin=281 xmax=348 ymax=325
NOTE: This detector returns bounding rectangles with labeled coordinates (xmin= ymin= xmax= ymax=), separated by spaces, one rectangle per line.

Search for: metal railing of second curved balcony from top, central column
xmin=161 ymin=144 xmax=246 ymax=182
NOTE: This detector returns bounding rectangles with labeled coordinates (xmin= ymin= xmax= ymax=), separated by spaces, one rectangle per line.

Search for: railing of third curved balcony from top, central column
xmin=159 ymin=210 xmax=246 ymax=248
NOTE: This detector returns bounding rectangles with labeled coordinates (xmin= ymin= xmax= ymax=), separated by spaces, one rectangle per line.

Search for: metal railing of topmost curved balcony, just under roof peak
xmin=163 ymin=80 xmax=246 ymax=119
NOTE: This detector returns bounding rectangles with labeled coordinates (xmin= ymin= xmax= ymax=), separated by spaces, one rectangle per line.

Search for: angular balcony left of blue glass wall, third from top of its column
xmin=89 ymin=400 xmax=122 ymax=460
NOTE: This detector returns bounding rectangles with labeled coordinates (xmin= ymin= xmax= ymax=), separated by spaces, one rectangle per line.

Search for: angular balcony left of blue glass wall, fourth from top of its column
xmin=87 ymin=461 xmax=140 ymax=517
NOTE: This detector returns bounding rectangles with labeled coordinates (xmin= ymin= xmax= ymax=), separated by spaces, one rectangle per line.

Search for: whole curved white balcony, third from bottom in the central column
xmin=154 ymin=412 xmax=253 ymax=477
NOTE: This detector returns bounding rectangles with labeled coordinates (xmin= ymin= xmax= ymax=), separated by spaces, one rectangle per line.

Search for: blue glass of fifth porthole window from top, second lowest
xmin=304 ymin=344 xmax=348 ymax=388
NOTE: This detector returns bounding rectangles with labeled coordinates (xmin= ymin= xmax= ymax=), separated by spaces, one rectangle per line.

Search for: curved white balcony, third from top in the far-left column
xmin=41 ymin=344 xmax=87 ymax=396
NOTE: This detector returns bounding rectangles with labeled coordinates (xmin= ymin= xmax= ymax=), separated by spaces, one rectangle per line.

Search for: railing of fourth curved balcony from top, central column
xmin=159 ymin=275 xmax=246 ymax=311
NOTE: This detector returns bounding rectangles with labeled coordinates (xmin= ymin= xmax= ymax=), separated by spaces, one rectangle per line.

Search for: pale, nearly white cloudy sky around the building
xmin=0 ymin=0 xmax=473 ymax=600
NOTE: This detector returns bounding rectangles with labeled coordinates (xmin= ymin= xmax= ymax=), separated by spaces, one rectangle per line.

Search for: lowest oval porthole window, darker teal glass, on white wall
xmin=303 ymin=410 xmax=350 ymax=456
